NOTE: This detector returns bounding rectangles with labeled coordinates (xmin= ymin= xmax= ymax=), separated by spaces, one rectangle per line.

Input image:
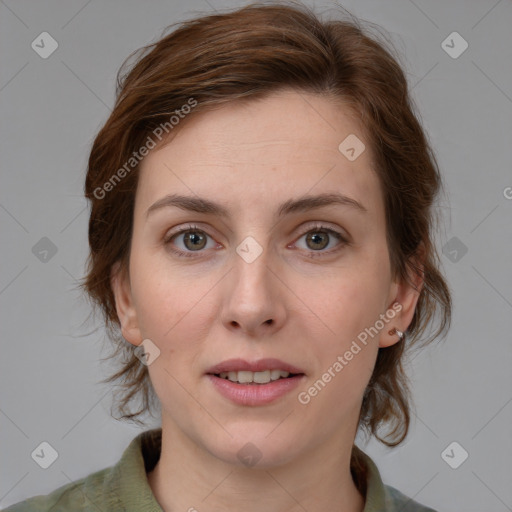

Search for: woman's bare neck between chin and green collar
xmin=148 ymin=418 xmax=364 ymax=512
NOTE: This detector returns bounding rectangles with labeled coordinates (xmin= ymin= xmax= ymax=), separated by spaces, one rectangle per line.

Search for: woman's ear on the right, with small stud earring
xmin=379 ymin=244 xmax=425 ymax=348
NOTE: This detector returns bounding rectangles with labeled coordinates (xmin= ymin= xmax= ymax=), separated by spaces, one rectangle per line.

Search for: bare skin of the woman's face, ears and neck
xmin=112 ymin=90 xmax=421 ymax=512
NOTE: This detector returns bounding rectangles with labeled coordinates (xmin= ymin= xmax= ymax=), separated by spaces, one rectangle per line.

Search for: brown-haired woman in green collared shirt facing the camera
xmin=7 ymin=3 xmax=451 ymax=512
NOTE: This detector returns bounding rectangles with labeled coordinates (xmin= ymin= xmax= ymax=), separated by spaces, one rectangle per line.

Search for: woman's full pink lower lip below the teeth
xmin=207 ymin=374 xmax=305 ymax=405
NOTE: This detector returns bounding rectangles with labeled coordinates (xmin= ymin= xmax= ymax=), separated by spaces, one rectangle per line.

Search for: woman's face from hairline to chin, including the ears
xmin=112 ymin=91 xmax=417 ymax=467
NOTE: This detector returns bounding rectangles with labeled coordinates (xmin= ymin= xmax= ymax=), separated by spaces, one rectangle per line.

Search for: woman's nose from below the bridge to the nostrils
xmin=221 ymin=249 xmax=286 ymax=338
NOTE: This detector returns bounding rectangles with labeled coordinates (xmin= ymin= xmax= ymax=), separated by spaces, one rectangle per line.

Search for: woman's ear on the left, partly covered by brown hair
xmin=110 ymin=262 xmax=142 ymax=345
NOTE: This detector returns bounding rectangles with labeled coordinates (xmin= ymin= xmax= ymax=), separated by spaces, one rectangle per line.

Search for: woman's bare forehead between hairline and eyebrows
xmin=136 ymin=91 xmax=382 ymax=217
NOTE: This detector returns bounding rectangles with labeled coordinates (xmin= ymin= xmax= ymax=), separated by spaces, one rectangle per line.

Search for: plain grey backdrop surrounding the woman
xmin=0 ymin=0 xmax=512 ymax=512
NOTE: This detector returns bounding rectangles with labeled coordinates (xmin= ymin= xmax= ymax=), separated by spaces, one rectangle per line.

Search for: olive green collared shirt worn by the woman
xmin=4 ymin=428 xmax=435 ymax=512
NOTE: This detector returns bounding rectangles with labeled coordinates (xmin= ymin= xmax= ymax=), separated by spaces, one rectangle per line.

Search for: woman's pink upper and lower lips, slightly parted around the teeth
xmin=206 ymin=358 xmax=306 ymax=406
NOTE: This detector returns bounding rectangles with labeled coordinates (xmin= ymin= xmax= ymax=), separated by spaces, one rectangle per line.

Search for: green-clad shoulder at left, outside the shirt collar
xmin=3 ymin=468 xmax=119 ymax=512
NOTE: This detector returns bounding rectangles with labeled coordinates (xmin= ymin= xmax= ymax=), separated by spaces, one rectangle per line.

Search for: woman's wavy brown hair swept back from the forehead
xmin=82 ymin=2 xmax=451 ymax=446
